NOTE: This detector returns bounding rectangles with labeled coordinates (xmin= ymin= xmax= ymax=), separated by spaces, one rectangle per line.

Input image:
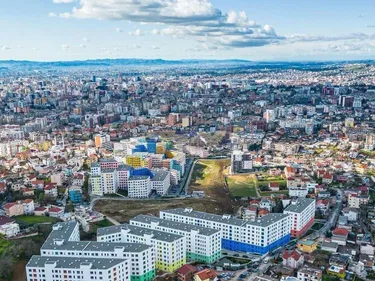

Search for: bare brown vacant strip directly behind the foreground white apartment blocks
xmin=94 ymin=198 xmax=234 ymax=222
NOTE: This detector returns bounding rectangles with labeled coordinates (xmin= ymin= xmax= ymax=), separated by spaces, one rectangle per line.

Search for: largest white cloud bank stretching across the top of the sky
xmin=53 ymin=0 xmax=285 ymax=47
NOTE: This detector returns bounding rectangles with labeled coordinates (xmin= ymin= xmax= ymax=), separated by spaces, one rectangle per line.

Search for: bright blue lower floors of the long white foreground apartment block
xmin=221 ymin=234 xmax=290 ymax=255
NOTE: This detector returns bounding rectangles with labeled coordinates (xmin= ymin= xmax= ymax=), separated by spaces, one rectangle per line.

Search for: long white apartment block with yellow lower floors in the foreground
xmin=97 ymin=224 xmax=186 ymax=272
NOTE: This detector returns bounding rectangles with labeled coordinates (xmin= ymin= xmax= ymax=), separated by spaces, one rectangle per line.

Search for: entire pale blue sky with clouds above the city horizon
xmin=0 ymin=0 xmax=375 ymax=61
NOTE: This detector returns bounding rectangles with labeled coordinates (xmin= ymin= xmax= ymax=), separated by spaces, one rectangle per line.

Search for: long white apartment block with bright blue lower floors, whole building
xmin=160 ymin=208 xmax=292 ymax=254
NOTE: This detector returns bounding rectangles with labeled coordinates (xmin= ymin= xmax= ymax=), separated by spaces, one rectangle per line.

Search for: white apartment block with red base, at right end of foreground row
xmin=284 ymin=198 xmax=315 ymax=237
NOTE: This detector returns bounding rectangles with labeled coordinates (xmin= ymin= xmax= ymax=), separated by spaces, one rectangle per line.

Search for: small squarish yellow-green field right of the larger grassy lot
xmin=226 ymin=175 xmax=258 ymax=197
